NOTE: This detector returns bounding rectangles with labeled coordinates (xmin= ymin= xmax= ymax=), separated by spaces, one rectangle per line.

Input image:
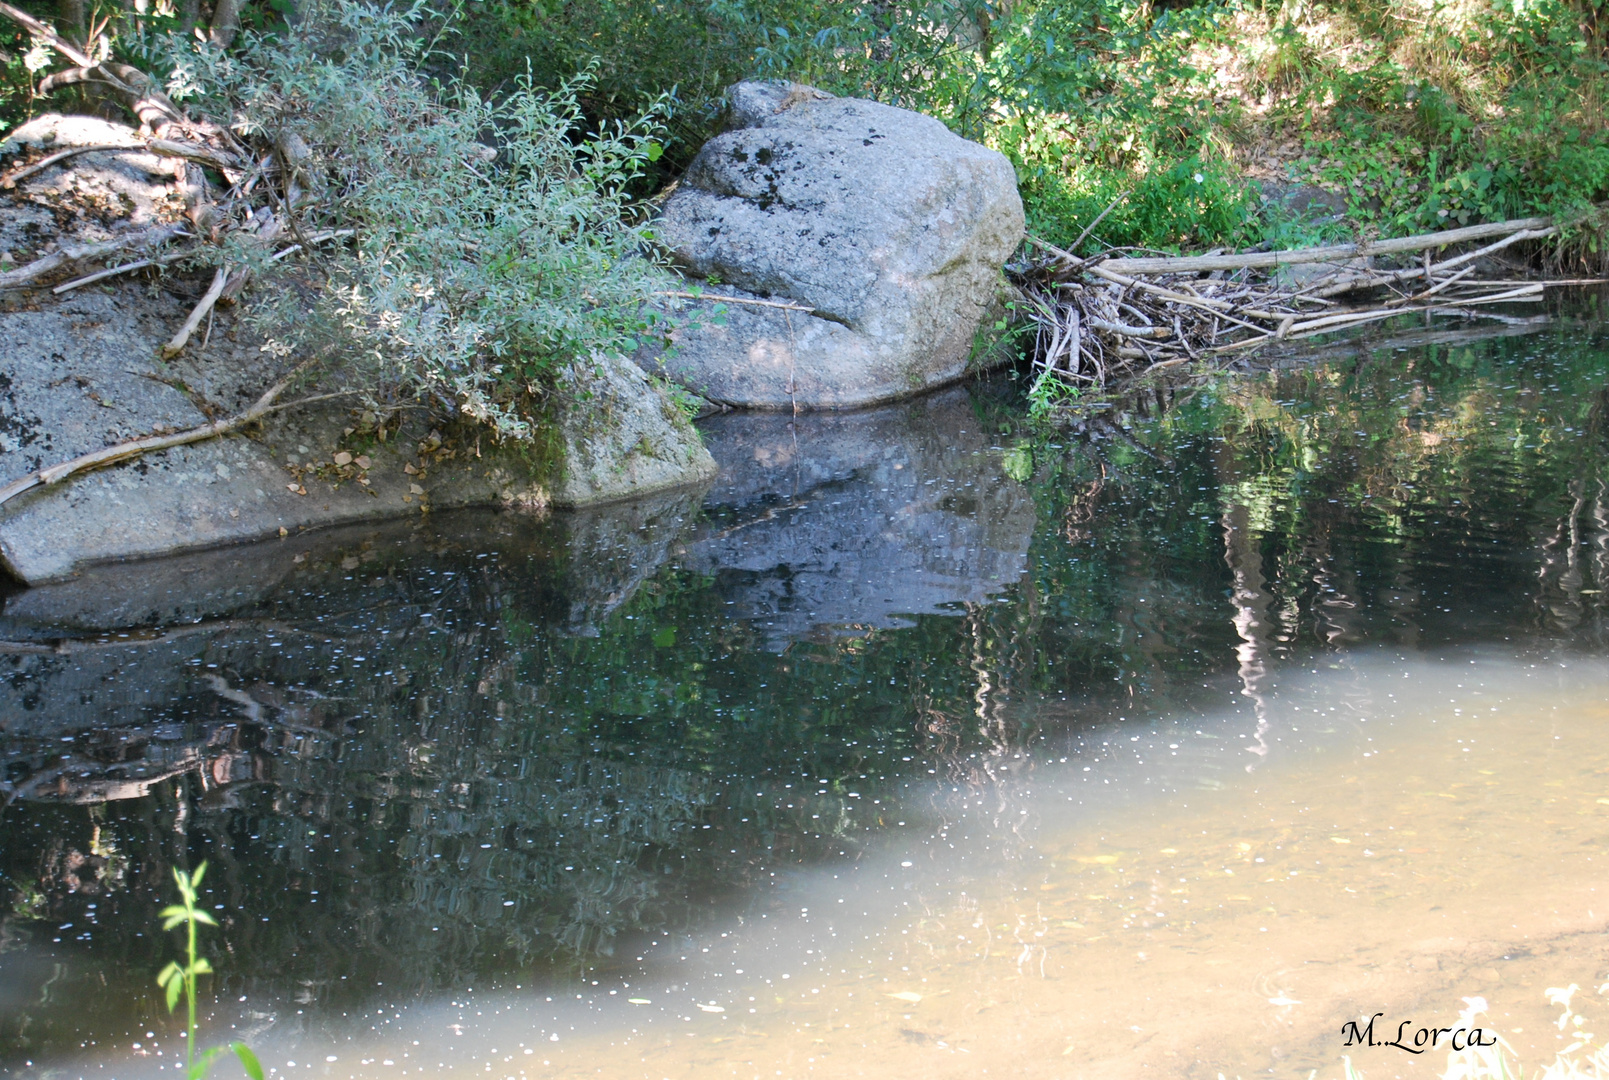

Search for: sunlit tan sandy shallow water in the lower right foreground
xmin=75 ymin=655 xmax=1609 ymax=1080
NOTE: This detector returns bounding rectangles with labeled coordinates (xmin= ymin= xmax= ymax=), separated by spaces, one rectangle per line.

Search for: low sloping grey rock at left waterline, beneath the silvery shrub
xmin=0 ymin=283 xmax=716 ymax=584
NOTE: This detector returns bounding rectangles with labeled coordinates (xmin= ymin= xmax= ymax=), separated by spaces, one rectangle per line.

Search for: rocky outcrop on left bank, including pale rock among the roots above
xmin=0 ymin=117 xmax=716 ymax=584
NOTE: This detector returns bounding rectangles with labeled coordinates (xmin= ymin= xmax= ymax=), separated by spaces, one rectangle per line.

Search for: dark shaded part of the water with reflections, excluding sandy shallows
xmin=0 ymin=298 xmax=1609 ymax=1075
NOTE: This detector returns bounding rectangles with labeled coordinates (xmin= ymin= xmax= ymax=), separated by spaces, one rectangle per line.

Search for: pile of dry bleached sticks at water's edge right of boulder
xmin=1014 ymin=208 xmax=1596 ymax=388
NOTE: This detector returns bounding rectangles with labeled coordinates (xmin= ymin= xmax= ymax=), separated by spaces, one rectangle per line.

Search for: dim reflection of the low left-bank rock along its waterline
xmin=0 ymin=491 xmax=697 ymax=753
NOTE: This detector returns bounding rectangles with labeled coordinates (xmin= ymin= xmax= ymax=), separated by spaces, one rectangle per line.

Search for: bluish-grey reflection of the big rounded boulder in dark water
xmin=681 ymin=388 xmax=1035 ymax=649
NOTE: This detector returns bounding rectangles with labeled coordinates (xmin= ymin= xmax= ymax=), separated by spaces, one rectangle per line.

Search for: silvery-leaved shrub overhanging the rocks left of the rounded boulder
xmin=148 ymin=0 xmax=663 ymax=438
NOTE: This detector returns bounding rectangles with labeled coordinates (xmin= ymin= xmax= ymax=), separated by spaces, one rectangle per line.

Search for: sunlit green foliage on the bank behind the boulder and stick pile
xmin=471 ymin=0 xmax=1609 ymax=251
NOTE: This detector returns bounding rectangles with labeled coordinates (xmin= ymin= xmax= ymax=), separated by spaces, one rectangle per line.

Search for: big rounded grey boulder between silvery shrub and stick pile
xmin=639 ymin=82 xmax=1023 ymax=409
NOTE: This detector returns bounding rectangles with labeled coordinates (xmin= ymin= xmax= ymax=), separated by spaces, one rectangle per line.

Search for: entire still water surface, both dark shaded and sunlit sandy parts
xmin=0 ymin=298 xmax=1609 ymax=1080
